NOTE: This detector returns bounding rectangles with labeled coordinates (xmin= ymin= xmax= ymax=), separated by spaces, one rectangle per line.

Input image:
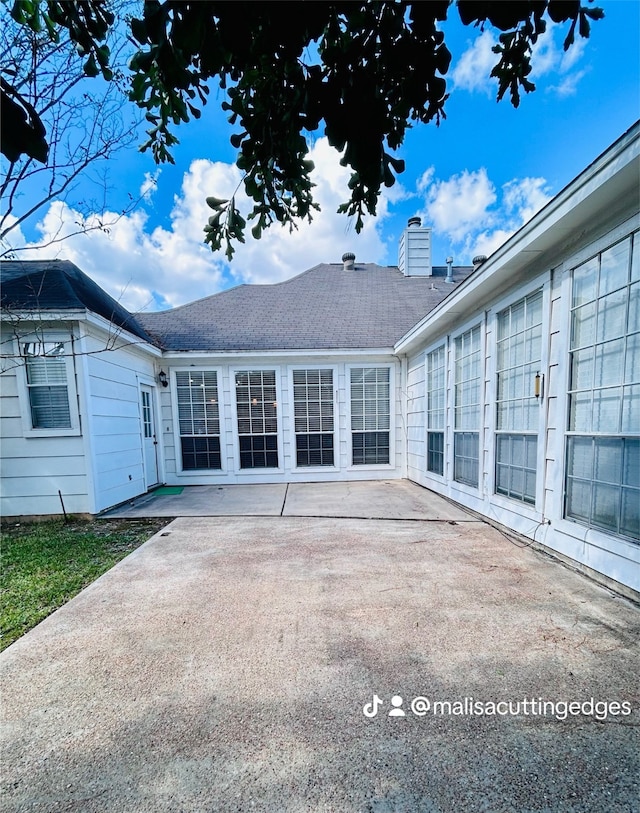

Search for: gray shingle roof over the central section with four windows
xmin=137 ymin=263 xmax=473 ymax=351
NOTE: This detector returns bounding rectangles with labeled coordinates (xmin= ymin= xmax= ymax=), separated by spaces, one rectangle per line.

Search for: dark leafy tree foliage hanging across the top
xmin=2 ymin=0 xmax=604 ymax=257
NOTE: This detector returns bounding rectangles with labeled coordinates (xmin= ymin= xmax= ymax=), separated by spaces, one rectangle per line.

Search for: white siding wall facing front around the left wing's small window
xmin=0 ymin=322 xmax=91 ymax=517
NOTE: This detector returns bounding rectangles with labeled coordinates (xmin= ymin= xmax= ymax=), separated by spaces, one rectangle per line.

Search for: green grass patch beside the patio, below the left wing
xmin=0 ymin=519 xmax=171 ymax=651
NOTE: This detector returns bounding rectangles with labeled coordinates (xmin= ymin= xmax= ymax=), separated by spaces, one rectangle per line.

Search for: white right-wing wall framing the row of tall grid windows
xmin=407 ymin=214 xmax=640 ymax=591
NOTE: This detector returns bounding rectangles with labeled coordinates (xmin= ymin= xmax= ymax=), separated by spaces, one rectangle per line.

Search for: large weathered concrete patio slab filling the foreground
xmin=0 ymin=484 xmax=640 ymax=813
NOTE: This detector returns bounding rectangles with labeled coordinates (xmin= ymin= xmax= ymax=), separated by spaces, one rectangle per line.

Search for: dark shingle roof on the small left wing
xmin=0 ymin=260 xmax=152 ymax=342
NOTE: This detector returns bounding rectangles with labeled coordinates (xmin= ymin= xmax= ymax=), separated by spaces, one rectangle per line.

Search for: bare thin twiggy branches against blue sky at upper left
xmin=0 ymin=0 xmax=141 ymax=257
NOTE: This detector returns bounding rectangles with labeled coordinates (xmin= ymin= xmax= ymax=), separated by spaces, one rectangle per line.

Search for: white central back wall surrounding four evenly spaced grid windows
xmin=160 ymin=353 xmax=406 ymax=485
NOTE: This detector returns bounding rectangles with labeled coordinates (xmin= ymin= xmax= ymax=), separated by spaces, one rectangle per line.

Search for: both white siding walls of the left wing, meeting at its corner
xmin=0 ymin=322 xmax=161 ymax=517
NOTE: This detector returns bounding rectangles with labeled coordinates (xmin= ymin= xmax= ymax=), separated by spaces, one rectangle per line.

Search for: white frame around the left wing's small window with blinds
xmin=14 ymin=332 xmax=82 ymax=438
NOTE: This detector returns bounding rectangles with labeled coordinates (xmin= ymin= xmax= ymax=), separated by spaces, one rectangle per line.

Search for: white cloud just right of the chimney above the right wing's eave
xmin=418 ymin=168 xmax=551 ymax=262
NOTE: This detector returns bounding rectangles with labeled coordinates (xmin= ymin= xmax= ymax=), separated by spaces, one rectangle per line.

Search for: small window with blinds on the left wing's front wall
xmin=22 ymin=341 xmax=71 ymax=429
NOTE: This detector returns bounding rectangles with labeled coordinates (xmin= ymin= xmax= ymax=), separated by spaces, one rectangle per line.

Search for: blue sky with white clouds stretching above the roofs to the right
xmin=6 ymin=0 xmax=640 ymax=310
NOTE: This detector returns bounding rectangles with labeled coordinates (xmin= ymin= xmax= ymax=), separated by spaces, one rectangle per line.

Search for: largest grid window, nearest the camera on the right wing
xmin=565 ymin=232 xmax=640 ymax=542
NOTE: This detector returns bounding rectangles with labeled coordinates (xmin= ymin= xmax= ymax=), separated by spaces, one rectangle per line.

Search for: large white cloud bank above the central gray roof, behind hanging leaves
xmin=6 ymin=138 xmax=390 ymax=310
